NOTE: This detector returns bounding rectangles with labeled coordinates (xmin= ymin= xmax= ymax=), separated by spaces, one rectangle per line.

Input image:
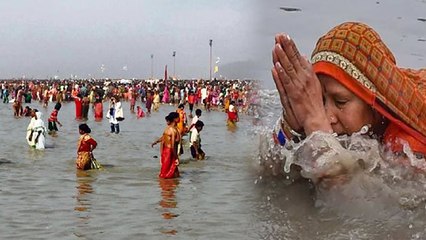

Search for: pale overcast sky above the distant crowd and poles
xmin=0 ymin=0 xmax=259 ymax=78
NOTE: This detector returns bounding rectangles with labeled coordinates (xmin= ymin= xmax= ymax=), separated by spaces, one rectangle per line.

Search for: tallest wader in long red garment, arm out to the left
xmin=151 ymin=112 xmax=180 ymax=178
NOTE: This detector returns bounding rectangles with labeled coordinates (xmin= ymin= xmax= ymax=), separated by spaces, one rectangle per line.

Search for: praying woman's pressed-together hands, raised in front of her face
xmin=272 ymin=34 xmax=333 ymax=135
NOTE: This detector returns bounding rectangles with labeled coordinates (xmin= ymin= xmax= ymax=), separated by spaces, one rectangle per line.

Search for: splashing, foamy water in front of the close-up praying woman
xmin=256 ymin=90 xmax=426 ymax=238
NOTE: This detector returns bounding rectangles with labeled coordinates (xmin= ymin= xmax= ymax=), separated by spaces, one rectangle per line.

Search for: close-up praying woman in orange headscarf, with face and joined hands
xmin=272 ymin=22 xmax=426 ymax=184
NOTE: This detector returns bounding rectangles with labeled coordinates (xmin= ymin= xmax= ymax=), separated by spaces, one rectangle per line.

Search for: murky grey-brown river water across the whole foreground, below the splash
xmin=0 ymin=94 xmax=426 ymax=239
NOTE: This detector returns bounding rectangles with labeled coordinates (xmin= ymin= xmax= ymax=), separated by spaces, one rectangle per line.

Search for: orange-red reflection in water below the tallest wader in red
xmin=158 ymin=178 xmax=179 ymax=235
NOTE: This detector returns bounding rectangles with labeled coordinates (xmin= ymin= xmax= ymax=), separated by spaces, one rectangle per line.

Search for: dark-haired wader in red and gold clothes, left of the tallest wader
xmin=75 ymin=123 xmax=100 ymax=170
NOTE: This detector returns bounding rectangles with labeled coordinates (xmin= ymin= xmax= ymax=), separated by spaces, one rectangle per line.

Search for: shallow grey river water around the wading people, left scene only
xmin=0 ymin=100 xmax=258 ymax=239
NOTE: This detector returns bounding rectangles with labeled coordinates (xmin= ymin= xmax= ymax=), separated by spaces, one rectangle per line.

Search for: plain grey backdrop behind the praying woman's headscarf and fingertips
xmin=256 ymin=0 xmax=426 ymax=87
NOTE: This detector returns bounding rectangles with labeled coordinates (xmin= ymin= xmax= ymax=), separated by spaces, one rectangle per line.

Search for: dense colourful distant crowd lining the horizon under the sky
xmin=0 ymin=79 xmax=260 ymax=116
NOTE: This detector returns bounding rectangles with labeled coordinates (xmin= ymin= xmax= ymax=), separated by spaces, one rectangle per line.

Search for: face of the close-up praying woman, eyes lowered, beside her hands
xmin=318 ymin=75 xmax=377 ymax=135
